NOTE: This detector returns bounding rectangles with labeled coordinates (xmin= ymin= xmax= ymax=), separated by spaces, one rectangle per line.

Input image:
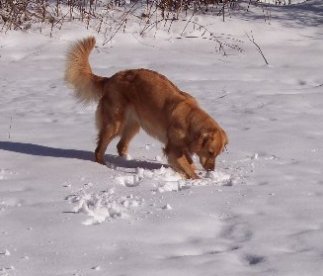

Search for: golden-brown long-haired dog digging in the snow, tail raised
xmin=65 ymin=37 xmax=228 ymax=179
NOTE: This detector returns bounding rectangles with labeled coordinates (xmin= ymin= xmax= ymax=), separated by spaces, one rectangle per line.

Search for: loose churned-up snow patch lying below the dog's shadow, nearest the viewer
xmin=67 ymin=189 xmax=143 ymax=225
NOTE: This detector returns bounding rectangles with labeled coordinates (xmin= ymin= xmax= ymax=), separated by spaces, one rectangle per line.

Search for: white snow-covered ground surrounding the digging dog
xmin=0 ymin=0 xmax=323 ymax=276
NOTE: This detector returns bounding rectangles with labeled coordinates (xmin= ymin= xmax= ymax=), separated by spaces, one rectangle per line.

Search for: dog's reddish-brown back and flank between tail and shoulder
xmin=102 ymin=69 xmax=197 ymax=143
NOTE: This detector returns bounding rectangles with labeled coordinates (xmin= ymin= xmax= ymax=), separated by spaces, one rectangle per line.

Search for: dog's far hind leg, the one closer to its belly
xmin=117 ymin=119 xmax=140 ymax=157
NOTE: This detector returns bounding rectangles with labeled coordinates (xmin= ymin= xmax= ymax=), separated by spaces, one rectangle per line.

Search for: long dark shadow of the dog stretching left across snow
xmin=0 ymin=141 xmax=168 ymax=170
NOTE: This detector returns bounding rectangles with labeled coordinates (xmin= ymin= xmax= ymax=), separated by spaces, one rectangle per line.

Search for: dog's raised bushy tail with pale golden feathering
xmin=65 ymin=36 xmax=107 ymax=103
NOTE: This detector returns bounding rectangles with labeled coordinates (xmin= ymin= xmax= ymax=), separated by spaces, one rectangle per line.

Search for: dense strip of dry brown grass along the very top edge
xmin=0 ymin=0 xmax=251 ymax=31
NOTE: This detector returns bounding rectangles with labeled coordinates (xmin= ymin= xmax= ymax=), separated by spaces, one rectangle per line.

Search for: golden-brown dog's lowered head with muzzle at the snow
xmin=194 ymin=128 xmax=228 ymax=171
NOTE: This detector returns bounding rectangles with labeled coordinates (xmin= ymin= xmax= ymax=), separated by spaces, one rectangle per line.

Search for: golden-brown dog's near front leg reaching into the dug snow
xmin=164 ymin=144 xmax=199 ymax=179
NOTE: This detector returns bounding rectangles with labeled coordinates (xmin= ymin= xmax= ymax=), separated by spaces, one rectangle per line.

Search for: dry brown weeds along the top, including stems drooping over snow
xmin=0 ymin=0 xmax=268 ymax=55
